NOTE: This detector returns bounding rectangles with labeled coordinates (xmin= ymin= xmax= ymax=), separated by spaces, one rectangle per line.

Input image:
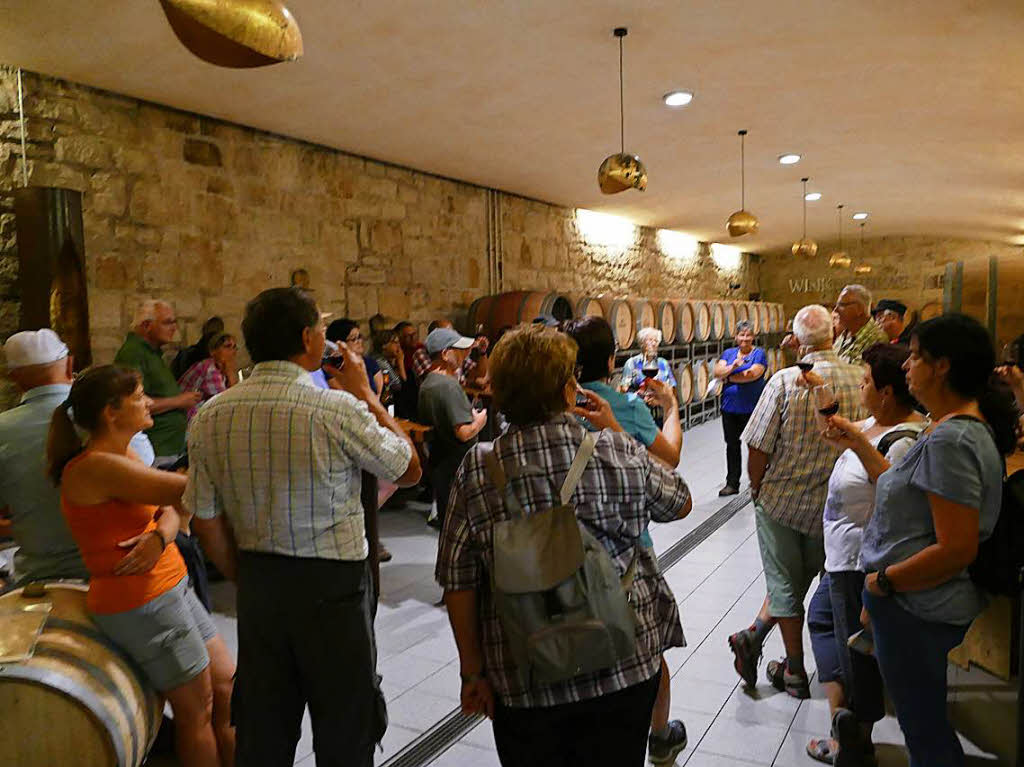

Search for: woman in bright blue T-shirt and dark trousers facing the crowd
xmin=714 ymin=319 xmax=768 ymax=497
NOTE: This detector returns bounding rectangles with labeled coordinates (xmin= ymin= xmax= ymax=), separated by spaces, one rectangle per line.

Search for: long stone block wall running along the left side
xmin=0 ymin=68 xmax=757 ymax=374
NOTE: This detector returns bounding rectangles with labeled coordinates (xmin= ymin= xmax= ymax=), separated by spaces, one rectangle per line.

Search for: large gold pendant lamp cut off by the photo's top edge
xmin=160 ymin=0 xmax=302 ymax=69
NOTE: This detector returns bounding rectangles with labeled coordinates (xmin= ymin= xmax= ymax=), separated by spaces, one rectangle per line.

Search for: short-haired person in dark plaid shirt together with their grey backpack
xmin=436 ymin=325 xmax=692 ymax=767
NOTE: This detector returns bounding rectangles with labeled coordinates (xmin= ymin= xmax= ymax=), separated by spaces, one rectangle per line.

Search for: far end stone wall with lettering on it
xmin=760 ymin=237 xmax=1024 ymax=316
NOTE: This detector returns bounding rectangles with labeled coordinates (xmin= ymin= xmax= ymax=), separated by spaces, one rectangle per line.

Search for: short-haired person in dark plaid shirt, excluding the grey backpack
xmin=436 ymin=326 xmax=692 ymax=767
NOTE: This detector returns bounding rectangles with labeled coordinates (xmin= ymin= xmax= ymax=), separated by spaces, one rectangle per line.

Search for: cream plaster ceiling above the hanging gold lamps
xmin=0 ymin=0 xmax=1024 ymax=251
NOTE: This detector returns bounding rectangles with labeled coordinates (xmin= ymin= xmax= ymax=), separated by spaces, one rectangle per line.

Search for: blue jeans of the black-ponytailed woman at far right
xmin=863 ymin=589 xmax=968 ymax=767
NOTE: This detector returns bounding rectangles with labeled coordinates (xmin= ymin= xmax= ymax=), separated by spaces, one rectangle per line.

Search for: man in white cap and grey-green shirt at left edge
xmin=0 ymin=328 xmax=153 ymax=585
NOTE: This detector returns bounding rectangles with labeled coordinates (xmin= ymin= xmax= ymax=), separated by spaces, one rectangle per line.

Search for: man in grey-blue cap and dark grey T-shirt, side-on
xmin=417 ymin=327 xmax=487 ymax=528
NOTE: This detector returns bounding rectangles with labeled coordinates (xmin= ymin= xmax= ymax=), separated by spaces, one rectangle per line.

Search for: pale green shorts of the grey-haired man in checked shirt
xmin=754 ymin=504 xmax=825 ymax=617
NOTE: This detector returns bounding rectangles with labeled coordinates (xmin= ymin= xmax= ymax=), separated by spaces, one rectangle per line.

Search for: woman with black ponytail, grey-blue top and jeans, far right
xmin=834 ymin=314 xmax=1018 ymax=767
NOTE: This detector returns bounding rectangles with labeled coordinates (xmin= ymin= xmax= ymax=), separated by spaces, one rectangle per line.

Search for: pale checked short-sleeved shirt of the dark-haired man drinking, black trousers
xmin=184 ymin=360 xmax=412 ymax=561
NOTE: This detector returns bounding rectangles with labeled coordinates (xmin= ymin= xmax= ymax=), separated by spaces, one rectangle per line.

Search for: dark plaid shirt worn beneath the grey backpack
xmin=435 ymin=415 xmax=690 ymax=708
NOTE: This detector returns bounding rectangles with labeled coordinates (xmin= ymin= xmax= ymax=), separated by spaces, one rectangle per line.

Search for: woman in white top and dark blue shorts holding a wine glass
xmin=807 ymin=344 xmax=925 ymax=767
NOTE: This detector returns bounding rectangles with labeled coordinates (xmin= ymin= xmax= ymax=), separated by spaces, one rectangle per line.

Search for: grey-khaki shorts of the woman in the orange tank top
xmin=92 ymin=577 xmax=217 ymax=692
